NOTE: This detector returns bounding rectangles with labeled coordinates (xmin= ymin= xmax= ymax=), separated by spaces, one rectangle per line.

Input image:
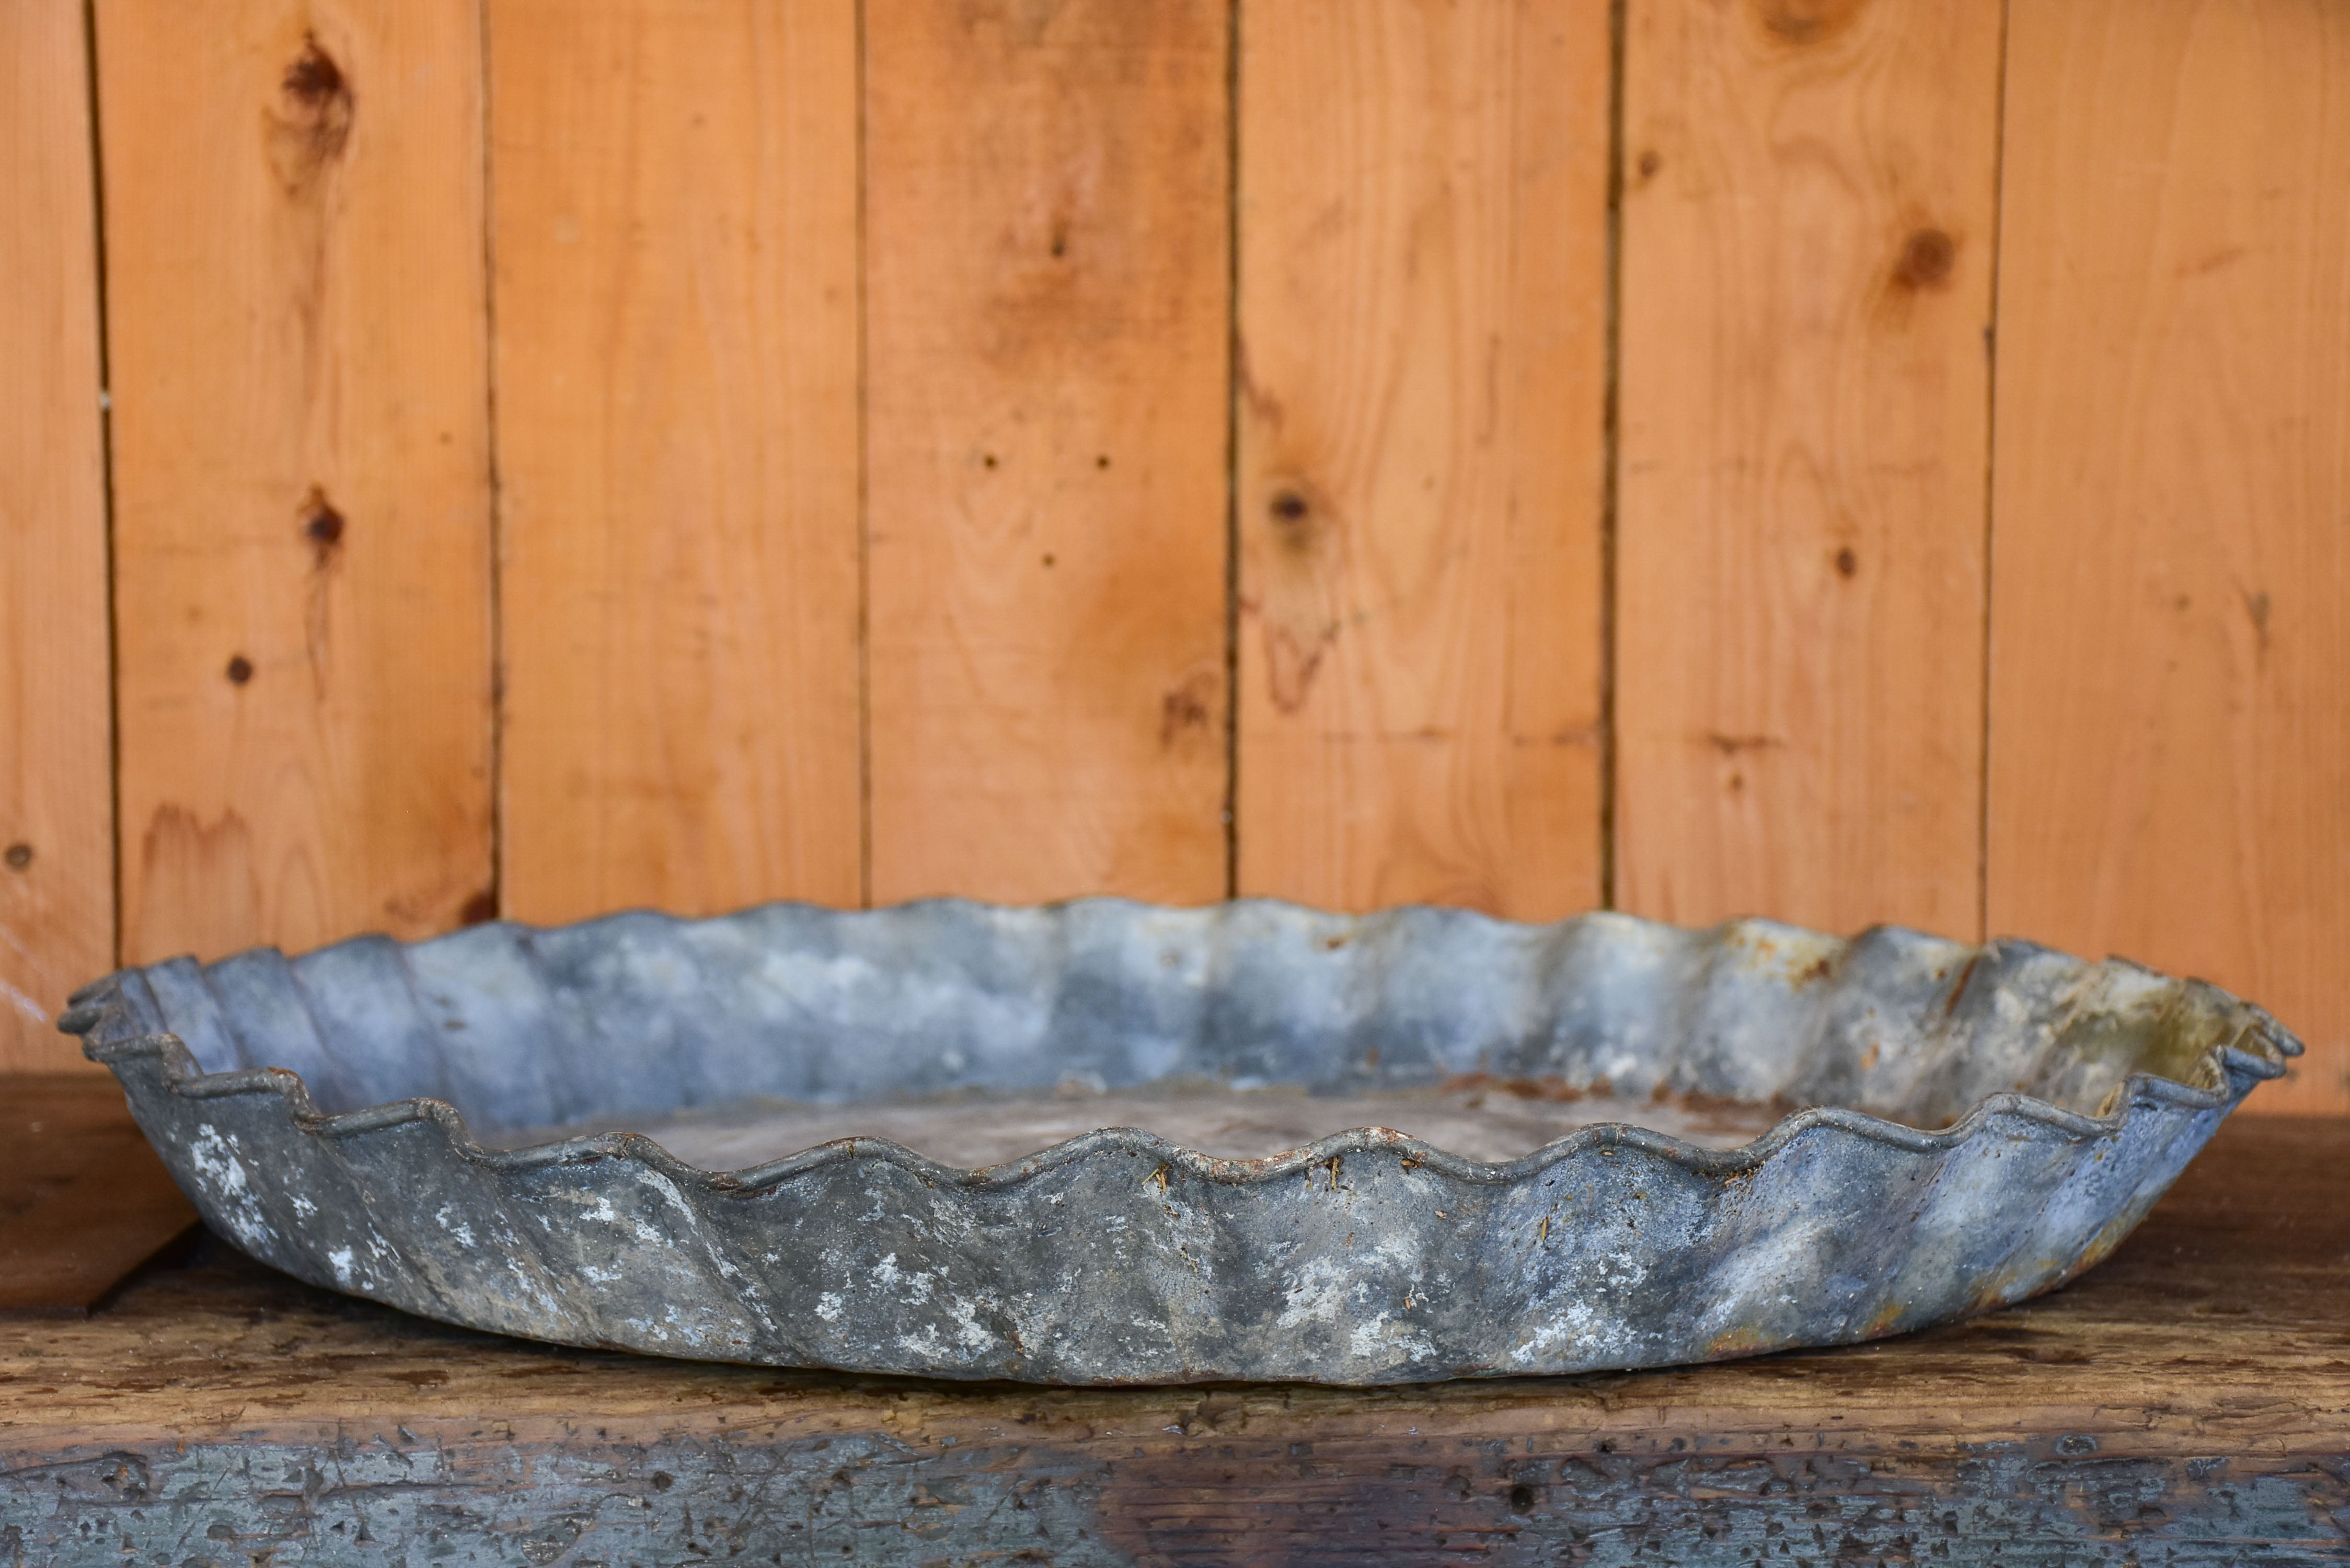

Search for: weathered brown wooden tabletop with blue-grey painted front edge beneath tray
xmin=0 ymin=1081 xmax=2350 ymax=1568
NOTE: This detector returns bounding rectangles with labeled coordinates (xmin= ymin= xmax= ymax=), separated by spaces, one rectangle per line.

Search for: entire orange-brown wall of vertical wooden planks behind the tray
xmin=0 ymin=0 xmax=2350 ymax=1112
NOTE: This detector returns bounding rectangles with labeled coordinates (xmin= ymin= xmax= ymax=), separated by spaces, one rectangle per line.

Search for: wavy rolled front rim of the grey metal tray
xmin=56 ymin=905 xmax=2303 ymax=1196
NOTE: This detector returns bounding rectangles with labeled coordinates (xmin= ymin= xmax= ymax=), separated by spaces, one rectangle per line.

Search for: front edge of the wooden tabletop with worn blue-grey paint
xmin=0 ymin=1429 xmax=2350 ymax=1568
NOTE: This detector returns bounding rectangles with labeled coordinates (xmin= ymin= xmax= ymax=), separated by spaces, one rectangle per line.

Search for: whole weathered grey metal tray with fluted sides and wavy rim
xmin=61 ymin=898 xmax=2301 ymax=1382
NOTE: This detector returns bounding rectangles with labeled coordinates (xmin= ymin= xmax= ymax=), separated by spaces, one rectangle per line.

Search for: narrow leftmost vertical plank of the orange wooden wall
xmin=0 ymin=2 xmax=115 ymax=1072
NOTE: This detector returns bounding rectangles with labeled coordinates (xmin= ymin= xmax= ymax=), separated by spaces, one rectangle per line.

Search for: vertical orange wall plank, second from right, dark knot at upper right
xmin=1617 ymin=0 xmax=2000 ymax=936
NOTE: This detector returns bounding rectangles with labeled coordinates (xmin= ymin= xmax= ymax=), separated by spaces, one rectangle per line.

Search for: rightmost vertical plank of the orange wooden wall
xmin=1988 ymin=0 xmax=2350 ymax=1128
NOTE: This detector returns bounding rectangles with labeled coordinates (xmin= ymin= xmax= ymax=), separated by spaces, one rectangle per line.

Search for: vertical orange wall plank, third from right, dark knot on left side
xmin=1238 ymin=0 xmax=1610 ymax=919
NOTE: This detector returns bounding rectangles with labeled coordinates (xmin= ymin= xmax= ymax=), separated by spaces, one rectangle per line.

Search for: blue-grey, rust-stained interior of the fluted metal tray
xmin=124 ymin=898 xmax=2254 ymax=1168
